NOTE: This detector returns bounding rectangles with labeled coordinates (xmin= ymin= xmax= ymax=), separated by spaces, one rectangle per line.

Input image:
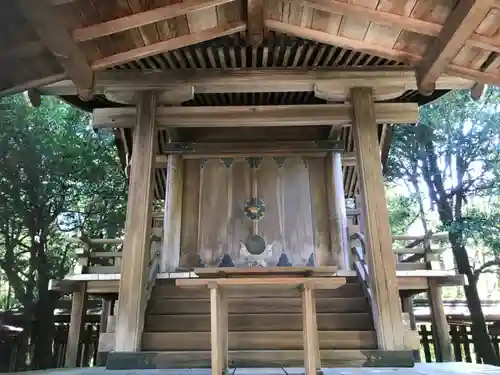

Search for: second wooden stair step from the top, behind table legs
xmin=147 ymin=297 xmax=369 ymax=319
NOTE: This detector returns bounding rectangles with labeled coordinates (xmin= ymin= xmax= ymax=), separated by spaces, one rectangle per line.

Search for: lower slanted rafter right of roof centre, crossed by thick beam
xmin=264 ymin=20 xmax=500 ymax=88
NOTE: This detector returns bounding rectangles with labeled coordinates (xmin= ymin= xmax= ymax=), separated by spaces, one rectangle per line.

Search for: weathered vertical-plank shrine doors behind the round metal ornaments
xmin=181 ymin=157 xmax=333 ymax=267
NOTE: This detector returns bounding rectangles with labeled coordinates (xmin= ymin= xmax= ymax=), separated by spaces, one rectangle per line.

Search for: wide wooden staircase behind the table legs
xmin=142 ymin=278 xmax=377 ymax=368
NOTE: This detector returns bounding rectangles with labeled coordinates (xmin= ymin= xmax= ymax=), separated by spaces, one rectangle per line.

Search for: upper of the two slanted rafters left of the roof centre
xmin=73 ymin=0 xmax=233 ymax=42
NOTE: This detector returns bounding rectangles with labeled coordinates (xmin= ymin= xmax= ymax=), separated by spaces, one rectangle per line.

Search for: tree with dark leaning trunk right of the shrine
xmin=389 ymin=89 xmax=500 ymax=364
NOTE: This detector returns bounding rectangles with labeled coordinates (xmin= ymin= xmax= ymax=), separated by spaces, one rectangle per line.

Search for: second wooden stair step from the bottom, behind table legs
xmin=142 ymin=331 xmax=377 ymax=351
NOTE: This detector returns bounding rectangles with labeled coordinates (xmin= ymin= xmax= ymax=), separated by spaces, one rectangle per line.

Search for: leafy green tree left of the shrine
xmin=0 ymin=95 xmax=126 ymax=368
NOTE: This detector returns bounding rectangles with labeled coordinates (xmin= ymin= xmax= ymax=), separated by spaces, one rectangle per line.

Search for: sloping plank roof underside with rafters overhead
xmin=0 ymin=0 xmax=500 ymax=94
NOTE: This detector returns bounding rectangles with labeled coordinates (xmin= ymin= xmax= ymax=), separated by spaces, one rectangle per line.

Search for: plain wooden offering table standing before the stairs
xmin=176 ymin=268 xmax=346 ymax=375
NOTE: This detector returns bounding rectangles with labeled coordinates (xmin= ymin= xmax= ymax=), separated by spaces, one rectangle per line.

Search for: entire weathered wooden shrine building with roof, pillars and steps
xmin=0 ymin=0 xmax=500 ymax=375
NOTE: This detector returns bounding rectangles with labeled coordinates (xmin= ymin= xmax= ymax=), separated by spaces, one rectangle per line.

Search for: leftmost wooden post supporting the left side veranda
xmin=64 ymin=282 xmax=87 ymax=368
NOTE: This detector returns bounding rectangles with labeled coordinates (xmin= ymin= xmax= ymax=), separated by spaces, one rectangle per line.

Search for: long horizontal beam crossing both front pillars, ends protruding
xmin=93 ymin=103 xmax=418 ymax=128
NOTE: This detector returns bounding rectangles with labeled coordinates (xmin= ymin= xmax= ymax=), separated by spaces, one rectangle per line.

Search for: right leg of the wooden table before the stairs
xmin=302 ymin=285 xmax=321 ymax=375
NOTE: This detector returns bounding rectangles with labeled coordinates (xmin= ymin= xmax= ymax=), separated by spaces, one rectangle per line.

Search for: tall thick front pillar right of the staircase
xmin=350 ymin=87 xmax=404 ymax=350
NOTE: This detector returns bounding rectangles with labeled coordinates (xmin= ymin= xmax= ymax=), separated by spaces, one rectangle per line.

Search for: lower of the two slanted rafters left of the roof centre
xmin=92 ymin=21 xmax=247 ymax=70
